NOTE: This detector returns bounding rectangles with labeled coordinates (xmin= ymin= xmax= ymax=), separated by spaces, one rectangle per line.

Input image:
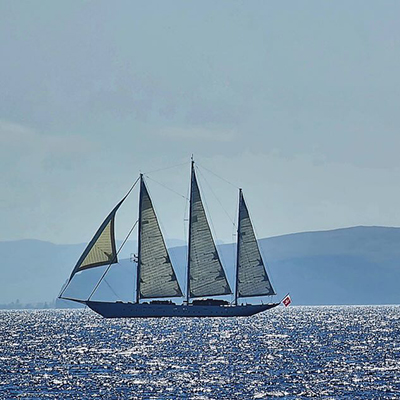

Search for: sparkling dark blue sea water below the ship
xmin=0 ymin=306 xmax=400 ymax=400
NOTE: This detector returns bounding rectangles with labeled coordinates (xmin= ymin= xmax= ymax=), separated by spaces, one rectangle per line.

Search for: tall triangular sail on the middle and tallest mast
xmin=188 ymin=163 xmax=232 ymax=297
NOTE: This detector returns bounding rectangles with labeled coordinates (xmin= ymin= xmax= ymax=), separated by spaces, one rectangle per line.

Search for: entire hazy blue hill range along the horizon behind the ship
xmin=0 ymin=227 xmax=400 ymax=305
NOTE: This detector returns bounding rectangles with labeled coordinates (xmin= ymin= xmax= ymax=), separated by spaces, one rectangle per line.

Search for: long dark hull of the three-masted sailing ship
xmin=85 ymin=301 xmax=279 ymax=318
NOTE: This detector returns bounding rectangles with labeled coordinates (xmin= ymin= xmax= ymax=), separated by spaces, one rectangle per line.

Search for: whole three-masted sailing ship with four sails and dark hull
xmin=59 ymin=158 xmax=280 ymax=318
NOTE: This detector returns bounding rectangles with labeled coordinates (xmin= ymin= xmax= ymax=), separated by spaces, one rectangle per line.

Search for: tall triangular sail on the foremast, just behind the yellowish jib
xmin=138 ymin=177 xmax=182 ymax=298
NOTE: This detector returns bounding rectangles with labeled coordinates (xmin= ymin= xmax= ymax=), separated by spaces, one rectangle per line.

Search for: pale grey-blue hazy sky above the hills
xmin=0 ymin=0 xmax=400 ymax=243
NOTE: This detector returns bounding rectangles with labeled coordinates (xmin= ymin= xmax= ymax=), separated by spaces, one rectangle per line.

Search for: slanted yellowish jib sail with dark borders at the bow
xmin=69 ymin=198 xmax=125 ymax=281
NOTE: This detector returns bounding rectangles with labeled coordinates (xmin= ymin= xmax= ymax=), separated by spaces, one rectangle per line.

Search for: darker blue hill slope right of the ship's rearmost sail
xmin=261 ymin=226 xmax=400 ymax=305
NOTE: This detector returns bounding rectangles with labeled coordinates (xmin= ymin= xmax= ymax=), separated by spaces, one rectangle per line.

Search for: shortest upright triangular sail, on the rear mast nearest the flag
xmin=236 ymin=190 xmax=275 ymax=297
